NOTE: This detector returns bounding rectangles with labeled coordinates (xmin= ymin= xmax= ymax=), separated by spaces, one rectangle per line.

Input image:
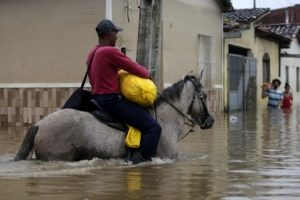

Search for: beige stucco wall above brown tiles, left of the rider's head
xmin=0 ymin=0 xmax=105 ymax=83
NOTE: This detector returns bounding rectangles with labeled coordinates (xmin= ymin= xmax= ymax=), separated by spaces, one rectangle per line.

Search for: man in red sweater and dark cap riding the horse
xmin=86 ymin=19 xmax=162 ymax=164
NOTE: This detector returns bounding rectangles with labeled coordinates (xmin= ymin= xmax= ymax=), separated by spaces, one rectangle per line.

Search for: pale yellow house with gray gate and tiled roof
xmin=223 ymin=8 xmax=290 ymax=111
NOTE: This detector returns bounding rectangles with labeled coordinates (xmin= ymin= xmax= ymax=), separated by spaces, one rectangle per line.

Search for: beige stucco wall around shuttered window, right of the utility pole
xmin=163 ymin=0 xmax=222 ymax=85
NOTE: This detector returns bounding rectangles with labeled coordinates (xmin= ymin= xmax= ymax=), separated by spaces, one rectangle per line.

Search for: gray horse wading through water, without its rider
xmin=14 ymin=73 xmax=214 ymax=161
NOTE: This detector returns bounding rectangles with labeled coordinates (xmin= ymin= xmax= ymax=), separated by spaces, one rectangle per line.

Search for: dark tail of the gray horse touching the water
xmin=14 ymin=125 xmax=39 ymax=161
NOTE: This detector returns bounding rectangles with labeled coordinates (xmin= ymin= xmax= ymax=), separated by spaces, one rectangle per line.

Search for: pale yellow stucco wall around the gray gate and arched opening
xmin=224 ymin=24 xmax=279 ymax=109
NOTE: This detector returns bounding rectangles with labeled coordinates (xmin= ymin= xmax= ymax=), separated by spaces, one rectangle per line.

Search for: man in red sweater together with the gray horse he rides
xmin=14 ymin=20 xmax=214 ymax=164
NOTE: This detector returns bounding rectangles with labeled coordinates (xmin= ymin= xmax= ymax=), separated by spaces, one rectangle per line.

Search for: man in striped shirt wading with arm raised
xmin=261 ymin=79 xmax=283 ymax=108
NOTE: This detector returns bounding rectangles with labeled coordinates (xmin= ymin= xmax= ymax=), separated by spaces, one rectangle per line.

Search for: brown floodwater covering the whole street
xmin=0 ymin=108 xmax=300 ymax=200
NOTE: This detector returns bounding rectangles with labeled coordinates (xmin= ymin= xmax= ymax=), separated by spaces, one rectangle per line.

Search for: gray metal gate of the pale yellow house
xmin=228 ymin=54 xmax=257 ymax=111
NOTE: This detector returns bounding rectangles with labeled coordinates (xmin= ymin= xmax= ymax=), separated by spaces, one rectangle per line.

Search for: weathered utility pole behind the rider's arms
xmin=136 ymin=0 xmax=163 ymax=90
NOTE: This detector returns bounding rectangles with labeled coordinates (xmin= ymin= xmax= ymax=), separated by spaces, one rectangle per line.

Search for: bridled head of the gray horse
xmin=184 ymin=70 xmax=215 ymax=129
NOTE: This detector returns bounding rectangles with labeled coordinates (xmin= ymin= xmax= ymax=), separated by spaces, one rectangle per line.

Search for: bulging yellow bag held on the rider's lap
xmin=119 ymin=70 xmax=157 ymax=107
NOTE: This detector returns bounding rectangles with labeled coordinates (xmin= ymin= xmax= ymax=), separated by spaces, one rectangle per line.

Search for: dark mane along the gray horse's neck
xmin=154 ymin=75 xmax=202 ymax=106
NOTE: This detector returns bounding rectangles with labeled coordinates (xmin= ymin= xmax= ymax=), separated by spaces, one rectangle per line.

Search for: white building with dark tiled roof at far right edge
xmin=258 ymin=4 xmax=300 ymax=106
